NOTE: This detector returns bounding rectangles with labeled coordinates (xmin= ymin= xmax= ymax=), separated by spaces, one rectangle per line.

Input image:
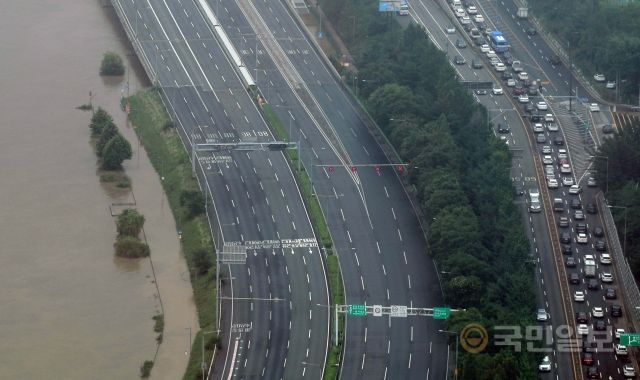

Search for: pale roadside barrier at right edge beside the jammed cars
xmin=596 ymin=192 xmax=640 ymax=331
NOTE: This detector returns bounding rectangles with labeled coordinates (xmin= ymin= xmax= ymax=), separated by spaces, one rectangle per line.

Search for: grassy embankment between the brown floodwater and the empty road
xmin=128 ymin=90 xmax=218 ymax=379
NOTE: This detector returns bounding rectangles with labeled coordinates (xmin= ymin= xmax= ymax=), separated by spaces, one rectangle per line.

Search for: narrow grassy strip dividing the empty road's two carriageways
xmin=262 ymin=104 xmax=344 ymax=379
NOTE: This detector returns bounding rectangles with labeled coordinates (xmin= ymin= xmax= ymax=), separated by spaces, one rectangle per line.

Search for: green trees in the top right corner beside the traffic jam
xmin=529 ymin=0 xmax=640 ymax=104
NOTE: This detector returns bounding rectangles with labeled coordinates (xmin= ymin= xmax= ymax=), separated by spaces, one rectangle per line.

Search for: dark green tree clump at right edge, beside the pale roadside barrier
xmin=594 ymin=121 xmax=640 ymax=279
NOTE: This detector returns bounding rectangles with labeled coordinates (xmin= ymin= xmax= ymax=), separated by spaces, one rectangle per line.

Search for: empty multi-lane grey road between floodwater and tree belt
xmin=114 ymin=0 xmax=449 ymax=378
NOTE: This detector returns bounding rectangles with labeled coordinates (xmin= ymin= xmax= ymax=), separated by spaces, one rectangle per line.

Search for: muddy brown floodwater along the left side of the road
xmin=0 ymin=0 xmax=198 ymax=379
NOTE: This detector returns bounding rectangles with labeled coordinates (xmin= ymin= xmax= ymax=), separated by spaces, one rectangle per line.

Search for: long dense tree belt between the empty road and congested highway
xmin=320 ymin=0 xmax=539 ymax=380
